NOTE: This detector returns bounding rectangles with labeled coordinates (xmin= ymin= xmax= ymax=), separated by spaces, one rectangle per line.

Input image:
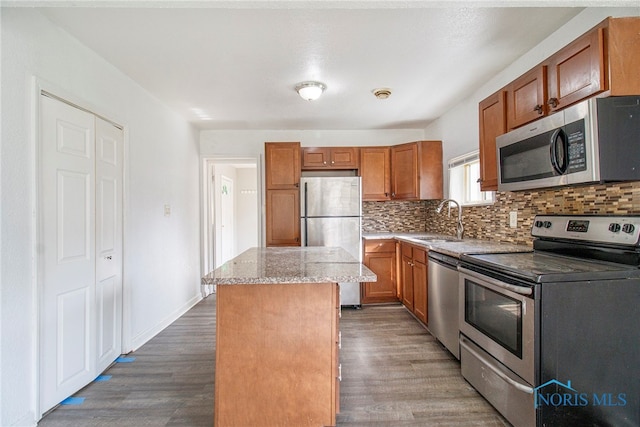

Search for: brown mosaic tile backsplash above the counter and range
xmin=362 ymin=182 xmax=640 ymax=244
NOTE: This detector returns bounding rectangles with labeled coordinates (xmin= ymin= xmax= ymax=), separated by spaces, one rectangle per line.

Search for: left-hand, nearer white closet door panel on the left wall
xmin=39 ymin=96 xmax=96 ymax=412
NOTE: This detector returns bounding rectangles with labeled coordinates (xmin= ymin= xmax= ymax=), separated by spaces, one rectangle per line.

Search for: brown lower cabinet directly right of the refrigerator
xmin=360 ymin=239 xmax=398 ymax=304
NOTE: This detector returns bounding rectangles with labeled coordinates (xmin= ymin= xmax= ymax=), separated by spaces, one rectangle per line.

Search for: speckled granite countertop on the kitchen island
xmin=202 ymin=247 xmax=377 ymax=285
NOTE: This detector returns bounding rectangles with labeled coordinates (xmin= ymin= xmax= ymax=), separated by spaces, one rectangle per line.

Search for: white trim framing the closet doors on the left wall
xmin=29 ymin=76 xmax=132 ymax=420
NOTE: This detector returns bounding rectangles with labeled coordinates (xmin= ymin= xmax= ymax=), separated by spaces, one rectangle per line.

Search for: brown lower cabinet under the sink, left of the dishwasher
xmin=400 ymin=243 xmax=428 ymax=325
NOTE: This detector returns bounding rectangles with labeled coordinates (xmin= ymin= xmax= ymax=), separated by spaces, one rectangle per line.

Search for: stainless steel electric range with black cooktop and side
xmin=459 ymin=215 xmax=640 ymax=426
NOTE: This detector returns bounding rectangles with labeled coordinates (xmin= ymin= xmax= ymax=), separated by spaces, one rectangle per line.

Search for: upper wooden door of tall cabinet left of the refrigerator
xmin=264 ymin=142 xmax=300 ymax=190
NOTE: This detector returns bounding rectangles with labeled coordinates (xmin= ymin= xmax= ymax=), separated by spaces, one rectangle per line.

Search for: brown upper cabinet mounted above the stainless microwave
xmin=506 ymin=17 xmax=640 ymax=130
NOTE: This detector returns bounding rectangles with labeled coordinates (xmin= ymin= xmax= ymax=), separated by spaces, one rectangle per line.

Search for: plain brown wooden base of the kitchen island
xmin=214 ymin=283 xmax=340 ymax=427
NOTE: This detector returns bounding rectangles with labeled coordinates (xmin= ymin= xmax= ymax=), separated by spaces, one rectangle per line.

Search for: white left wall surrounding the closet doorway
xmin=0 ymin=8 xmax=200 ymax=426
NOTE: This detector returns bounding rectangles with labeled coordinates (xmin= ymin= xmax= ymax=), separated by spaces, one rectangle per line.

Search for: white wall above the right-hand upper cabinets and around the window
xmin=425 ymin=7 xmax=640 ymax=194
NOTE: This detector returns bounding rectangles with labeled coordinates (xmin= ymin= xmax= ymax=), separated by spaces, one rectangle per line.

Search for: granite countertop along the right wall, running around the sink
xmin=362 ymin=232 xmax=533 ymax=258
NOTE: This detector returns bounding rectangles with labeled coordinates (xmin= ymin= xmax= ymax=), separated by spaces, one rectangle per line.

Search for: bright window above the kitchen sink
xmin=449 ymin=150 xmax=495 ymax=206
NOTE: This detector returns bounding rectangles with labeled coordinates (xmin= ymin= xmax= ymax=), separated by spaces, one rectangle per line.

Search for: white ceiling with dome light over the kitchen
xmin=23 ymin=0 xmax=630 ymax=129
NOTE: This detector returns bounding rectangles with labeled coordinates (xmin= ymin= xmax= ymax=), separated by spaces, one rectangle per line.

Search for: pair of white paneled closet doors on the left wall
xmin=38 ymin=96 xmax=124 ymax=413
